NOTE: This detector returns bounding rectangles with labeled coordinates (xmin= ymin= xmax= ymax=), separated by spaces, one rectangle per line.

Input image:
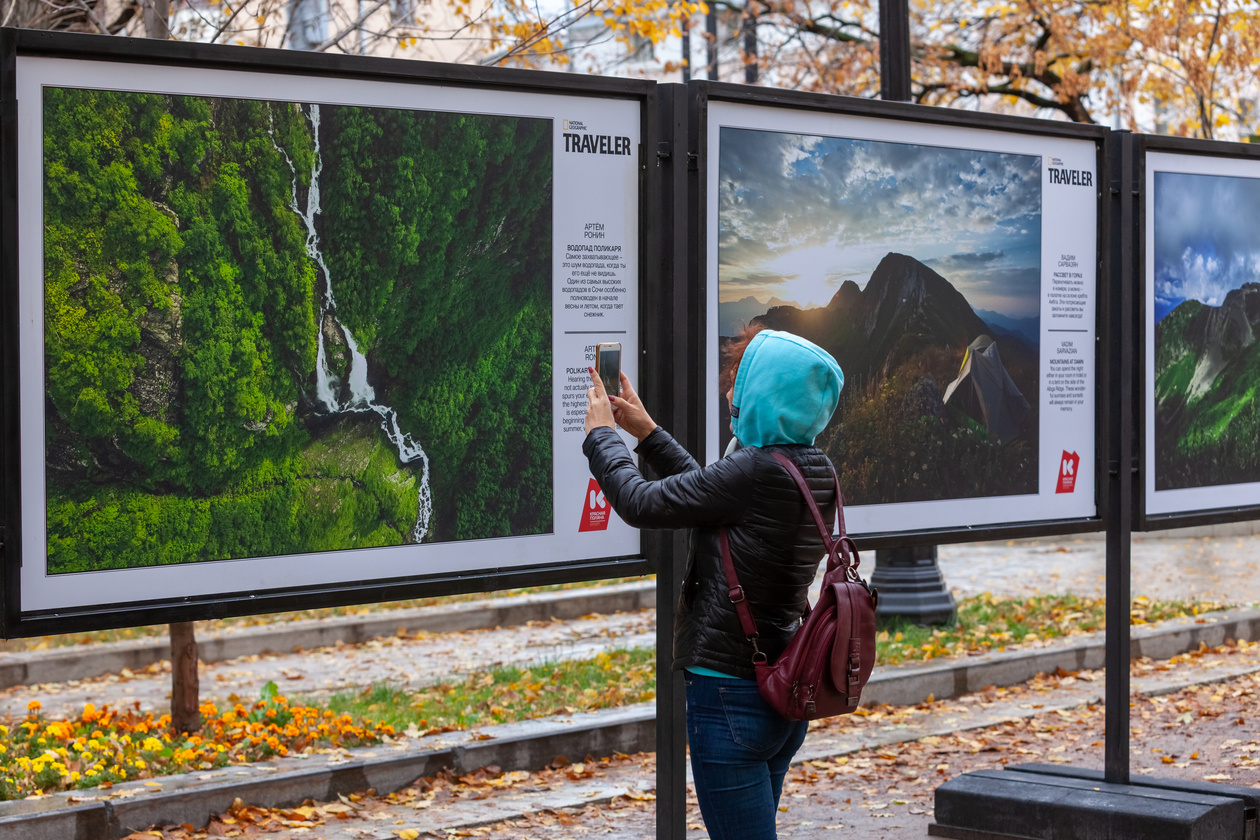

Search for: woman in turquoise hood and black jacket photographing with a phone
xmin=582 ymin=327 xmax=844 ymax=840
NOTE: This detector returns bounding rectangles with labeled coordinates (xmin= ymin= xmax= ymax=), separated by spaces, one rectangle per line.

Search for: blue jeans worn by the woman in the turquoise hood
xmin=684 ymin=671 xmax=809 ymax=840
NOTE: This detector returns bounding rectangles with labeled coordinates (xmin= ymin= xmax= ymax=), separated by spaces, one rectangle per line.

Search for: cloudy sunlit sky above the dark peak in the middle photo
xmin=718 ymin=128 xmax=1042 ymax=317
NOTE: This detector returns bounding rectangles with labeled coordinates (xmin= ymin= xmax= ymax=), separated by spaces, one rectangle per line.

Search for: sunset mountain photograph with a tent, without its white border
xmin=718 ymin=128 xmax=1042 ymax=505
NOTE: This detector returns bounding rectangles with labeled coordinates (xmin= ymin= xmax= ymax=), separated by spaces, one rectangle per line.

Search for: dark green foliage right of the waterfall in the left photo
xmin=321 ymin=108 xmax=552 ymax=539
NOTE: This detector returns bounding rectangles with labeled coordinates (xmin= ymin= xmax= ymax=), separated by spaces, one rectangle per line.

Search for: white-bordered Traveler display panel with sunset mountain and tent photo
xmin=707 ymin=102 xmax=1099 ymax=533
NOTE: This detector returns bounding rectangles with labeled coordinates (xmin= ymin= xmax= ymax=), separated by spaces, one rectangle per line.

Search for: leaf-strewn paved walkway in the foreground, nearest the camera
xmin=134 ymin=634 xmax=1260 ymax=840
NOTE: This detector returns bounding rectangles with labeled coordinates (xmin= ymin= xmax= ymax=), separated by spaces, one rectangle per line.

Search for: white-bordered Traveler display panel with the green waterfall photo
xmin=9 ymin=57 xmax=641 ymax=612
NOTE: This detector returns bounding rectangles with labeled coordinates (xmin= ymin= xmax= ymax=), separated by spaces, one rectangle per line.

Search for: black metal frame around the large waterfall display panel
xmin=0 ymin=29 xmax=665 ymax=637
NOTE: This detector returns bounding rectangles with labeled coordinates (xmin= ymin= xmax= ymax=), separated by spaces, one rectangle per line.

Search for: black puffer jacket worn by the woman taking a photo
xmin=582 ymin=427 xmax=835 ymax=680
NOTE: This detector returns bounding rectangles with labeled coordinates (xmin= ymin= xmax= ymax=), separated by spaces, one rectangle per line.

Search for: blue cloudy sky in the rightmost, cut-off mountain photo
xmin=1154 ymin=173 xmax=1260 ymax=321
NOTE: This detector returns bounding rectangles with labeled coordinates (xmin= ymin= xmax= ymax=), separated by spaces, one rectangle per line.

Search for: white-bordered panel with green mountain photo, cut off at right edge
xmin=1143 ymin=151 xmax=1260 ymax=515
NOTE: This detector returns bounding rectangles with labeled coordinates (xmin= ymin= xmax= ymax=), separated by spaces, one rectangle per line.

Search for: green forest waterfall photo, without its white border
xmin=43 ymin=88 xmax=552 ymax=573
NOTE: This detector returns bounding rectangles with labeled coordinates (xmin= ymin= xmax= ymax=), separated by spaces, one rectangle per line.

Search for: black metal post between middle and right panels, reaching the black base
xmin=1104 ymin=131 xmax=1137 ymax=785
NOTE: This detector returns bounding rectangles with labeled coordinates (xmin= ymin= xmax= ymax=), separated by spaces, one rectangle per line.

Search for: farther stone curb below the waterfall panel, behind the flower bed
xmin=0 ymin=581 xmax=656 ymax=695
